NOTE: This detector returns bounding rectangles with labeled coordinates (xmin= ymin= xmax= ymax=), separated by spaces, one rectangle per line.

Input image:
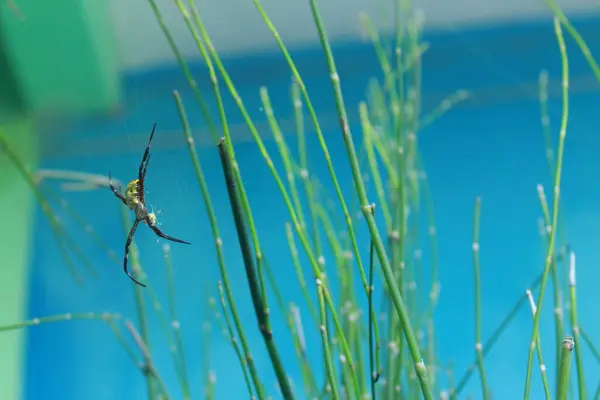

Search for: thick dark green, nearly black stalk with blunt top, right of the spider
xmin=218 ymin=138 xmax=294 ymax=400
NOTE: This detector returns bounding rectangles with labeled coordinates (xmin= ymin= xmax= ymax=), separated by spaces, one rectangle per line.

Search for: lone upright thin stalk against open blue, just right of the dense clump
xmin=473 ymin=197 xmax=490 ymax=400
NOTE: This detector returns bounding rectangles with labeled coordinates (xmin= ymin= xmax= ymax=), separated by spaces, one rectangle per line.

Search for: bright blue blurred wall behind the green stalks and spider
xmin=25 ymin=12 xmax=600 ymax=400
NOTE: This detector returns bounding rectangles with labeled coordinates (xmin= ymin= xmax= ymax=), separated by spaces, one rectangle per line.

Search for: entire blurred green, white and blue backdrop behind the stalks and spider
xmin=0 ymin=0 xmax=600 ymax=400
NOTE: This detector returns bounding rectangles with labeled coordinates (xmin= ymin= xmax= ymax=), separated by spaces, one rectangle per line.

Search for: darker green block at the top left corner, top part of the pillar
xmin=0 ymin=0 xmax=120 ymax=117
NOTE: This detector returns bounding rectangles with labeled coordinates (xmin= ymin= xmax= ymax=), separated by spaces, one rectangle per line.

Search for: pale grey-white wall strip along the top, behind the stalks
xmin=111 ymin=0 xmax=600 ymax=69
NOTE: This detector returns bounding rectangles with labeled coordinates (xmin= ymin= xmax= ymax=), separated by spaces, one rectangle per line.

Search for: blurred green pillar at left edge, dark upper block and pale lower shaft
xmin=0 ymin=0 xmax=121 ymax=400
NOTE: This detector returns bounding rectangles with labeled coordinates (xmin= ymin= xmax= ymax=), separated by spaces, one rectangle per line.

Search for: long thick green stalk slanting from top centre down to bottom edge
xmin=310 ymin=0 xmax=433 ymax=400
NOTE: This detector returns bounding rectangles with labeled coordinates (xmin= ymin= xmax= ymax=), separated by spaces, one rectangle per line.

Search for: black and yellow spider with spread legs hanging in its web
xmin=108 ymin=122 xmax=191 ymax=287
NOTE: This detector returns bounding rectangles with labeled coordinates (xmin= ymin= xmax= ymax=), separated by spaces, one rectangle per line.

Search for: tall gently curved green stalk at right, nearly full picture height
xmin=524 ymin=17 xmax=569 ymax=400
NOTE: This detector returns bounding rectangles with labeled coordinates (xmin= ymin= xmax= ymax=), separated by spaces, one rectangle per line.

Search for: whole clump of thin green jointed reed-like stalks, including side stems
xmin=0 ymin=0 xmax=600 ymax=400
